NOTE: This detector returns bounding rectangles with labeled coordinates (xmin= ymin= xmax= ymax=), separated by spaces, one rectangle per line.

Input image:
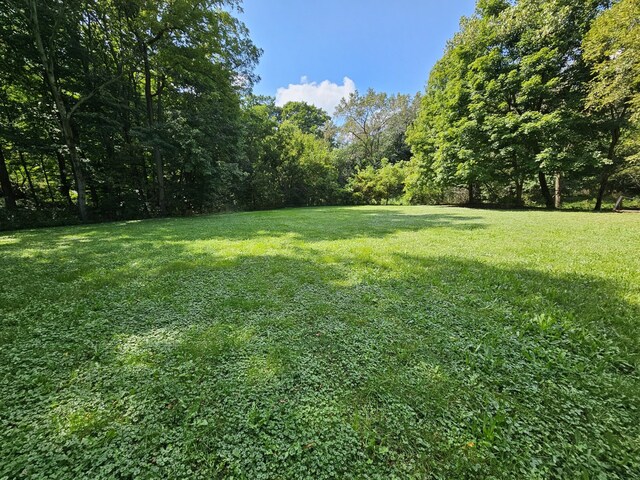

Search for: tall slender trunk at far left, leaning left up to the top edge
xmin=29 ymin=0 xmax=88 ymax=221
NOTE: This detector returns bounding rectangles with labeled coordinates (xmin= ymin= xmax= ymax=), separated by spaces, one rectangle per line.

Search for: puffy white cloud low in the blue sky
xmin=276 ymin=76 xmax=356 ymax=115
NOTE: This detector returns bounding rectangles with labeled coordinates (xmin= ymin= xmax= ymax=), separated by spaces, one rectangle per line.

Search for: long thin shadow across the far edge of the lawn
xmin=0 ymin=207 xmax=483 ymax=248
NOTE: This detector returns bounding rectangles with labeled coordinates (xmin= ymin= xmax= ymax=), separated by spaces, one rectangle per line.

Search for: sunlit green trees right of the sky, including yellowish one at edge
xmin=408 ymin=0 xmax=640 ymax=210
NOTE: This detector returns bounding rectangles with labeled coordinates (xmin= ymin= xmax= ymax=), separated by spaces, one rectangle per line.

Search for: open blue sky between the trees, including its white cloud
xmin=241 ymin=0 xmax=475 ymax=113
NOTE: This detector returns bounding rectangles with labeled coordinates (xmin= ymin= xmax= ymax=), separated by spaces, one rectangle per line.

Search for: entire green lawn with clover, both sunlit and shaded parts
xmin=0 ymin=207 xmax=640 ymax=479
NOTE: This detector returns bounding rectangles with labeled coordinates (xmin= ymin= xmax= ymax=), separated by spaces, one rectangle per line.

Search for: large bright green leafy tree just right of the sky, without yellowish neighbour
xmin=408 ymin=0 xmax=628 ymax=207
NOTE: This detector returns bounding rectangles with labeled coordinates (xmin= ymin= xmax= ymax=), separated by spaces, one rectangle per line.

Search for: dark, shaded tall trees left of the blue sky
xmin=0 ymin=0 xmax=260 ymax=219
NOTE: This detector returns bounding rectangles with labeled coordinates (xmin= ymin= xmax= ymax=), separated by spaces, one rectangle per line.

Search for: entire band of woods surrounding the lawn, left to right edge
xmin=0 ymin=0 xmax=640 ymax=228
